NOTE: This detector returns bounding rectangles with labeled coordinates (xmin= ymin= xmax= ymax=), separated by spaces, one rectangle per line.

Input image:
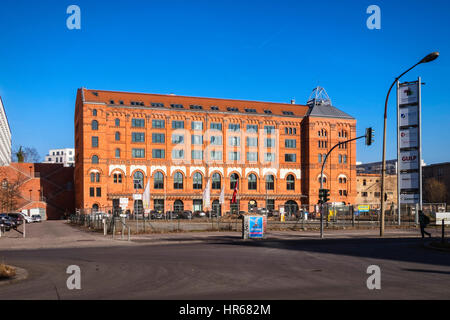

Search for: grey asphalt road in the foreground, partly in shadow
xmin=0 ymin=222 xmax=450 ymax=300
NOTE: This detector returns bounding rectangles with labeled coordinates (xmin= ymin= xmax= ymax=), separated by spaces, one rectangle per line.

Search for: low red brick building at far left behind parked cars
xmin=0 ymin=163 xmax=75 ymax=220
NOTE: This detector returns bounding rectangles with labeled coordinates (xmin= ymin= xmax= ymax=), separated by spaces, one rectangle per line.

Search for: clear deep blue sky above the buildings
xmin=0 ymin=0 xmax=450 ymax=164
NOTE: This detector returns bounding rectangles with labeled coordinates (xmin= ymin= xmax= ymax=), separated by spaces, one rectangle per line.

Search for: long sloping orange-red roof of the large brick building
xmin=82 ymin=88 xmax=309 ymax=118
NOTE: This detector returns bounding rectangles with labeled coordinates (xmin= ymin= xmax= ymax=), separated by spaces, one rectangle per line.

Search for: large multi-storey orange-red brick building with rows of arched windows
xmin=75 ymin=88 xmax=356 ymax=214
